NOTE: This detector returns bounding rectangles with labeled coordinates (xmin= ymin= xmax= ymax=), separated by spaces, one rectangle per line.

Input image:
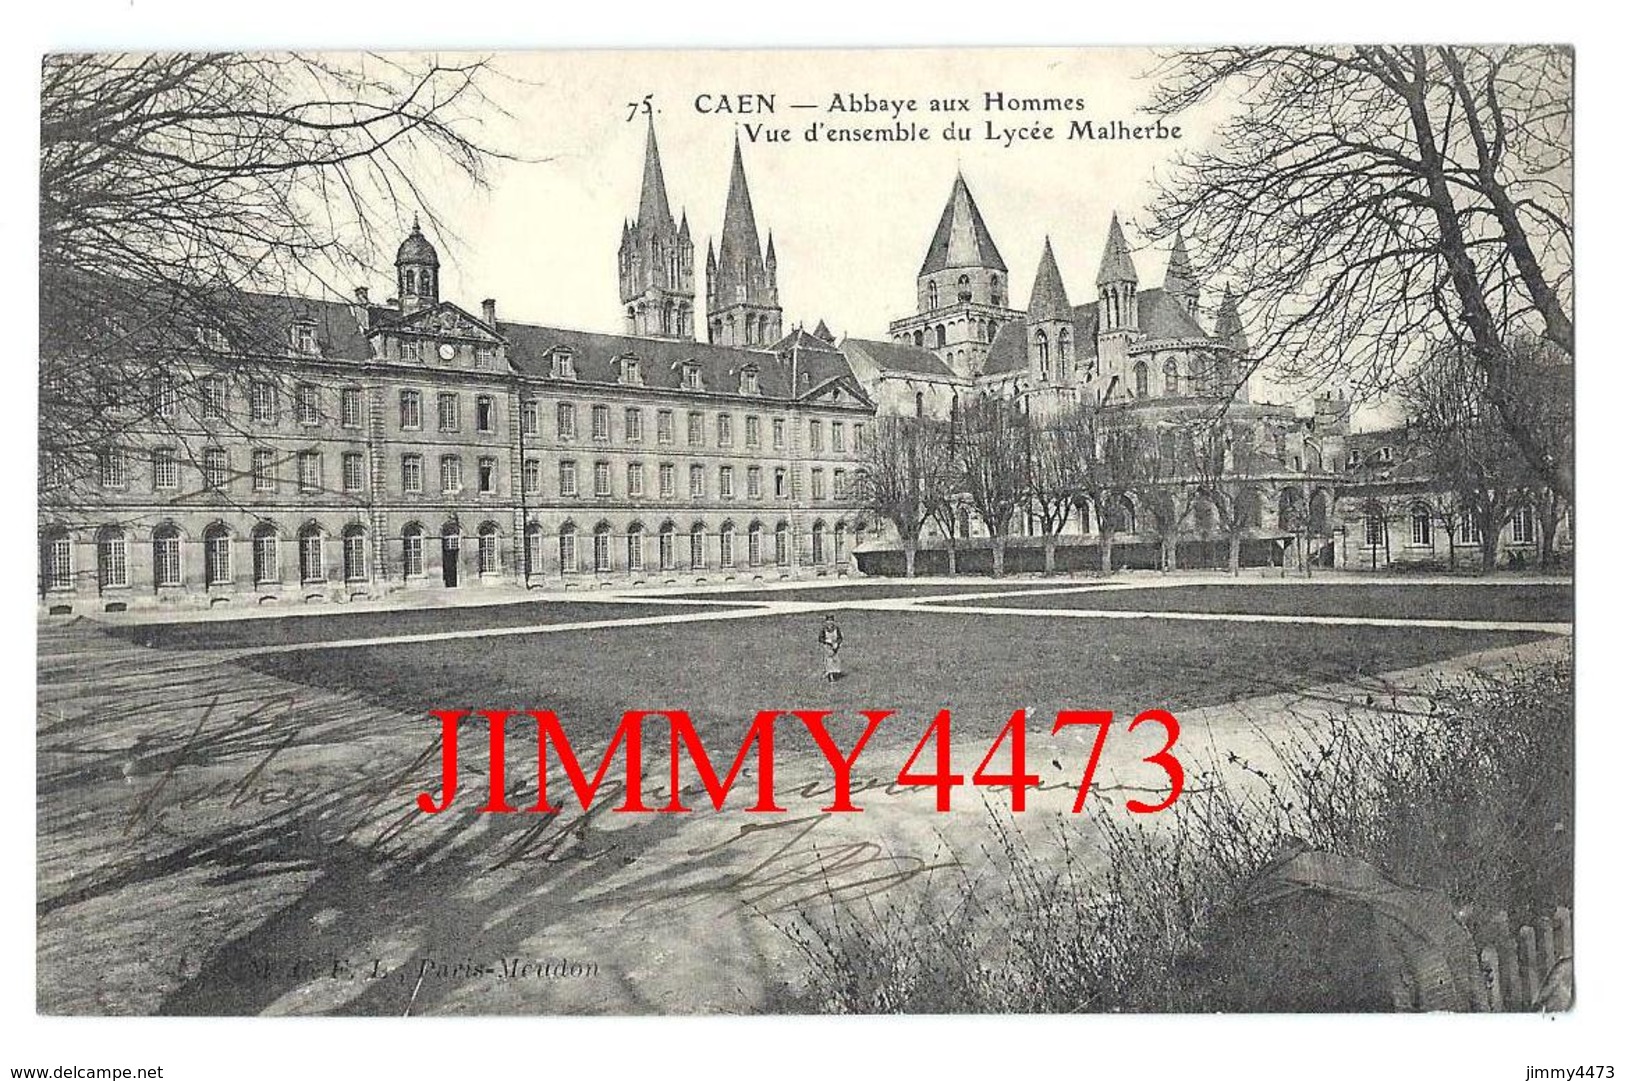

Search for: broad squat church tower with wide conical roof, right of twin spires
xmin=891 ymin=172 xmax=1021 ymax=377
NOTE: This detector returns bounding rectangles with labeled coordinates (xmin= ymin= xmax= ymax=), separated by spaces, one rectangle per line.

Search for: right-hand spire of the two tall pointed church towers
xmin=705 ymin=135 xmax=785 ymax=346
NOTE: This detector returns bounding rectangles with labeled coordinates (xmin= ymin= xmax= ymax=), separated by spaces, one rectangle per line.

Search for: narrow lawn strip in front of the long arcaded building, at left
xmin=107 ymin=598 xmax=747 ymax=649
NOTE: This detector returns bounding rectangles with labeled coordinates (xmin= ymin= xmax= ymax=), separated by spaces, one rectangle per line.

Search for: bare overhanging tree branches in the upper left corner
xmin=39 ymin=54 xmax=497 ymax=513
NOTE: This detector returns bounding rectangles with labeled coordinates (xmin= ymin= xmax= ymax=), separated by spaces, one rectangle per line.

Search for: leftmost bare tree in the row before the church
xmin=856 ymin=416 xmax=949 ymax=579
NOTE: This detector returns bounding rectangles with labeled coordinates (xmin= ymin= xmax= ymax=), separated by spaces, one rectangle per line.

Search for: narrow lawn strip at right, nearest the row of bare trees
xmin=929 ymin=582 xmax=1575 ymax=623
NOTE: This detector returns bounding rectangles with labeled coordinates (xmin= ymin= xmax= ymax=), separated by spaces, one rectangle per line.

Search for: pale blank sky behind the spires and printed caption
xmin=339 ymin=49 xmax=1345 ymax=416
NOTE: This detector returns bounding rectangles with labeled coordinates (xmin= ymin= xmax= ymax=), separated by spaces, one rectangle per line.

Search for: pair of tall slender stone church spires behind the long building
xmin=619 ymin=119 xmax=783 ymax=346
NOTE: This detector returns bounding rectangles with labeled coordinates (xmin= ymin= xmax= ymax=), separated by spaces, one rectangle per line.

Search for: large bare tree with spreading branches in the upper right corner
xmin=1154 ymin=46 xmax=1573 ymax=499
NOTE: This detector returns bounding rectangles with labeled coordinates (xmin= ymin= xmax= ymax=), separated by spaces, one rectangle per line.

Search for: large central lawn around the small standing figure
xmin=245 ymin=610 xmax=1539 ymax=751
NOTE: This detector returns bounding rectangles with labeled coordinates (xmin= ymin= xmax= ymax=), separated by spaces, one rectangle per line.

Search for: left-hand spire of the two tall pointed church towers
xmin=619 ymin=117 xmax=694 ymax=340
